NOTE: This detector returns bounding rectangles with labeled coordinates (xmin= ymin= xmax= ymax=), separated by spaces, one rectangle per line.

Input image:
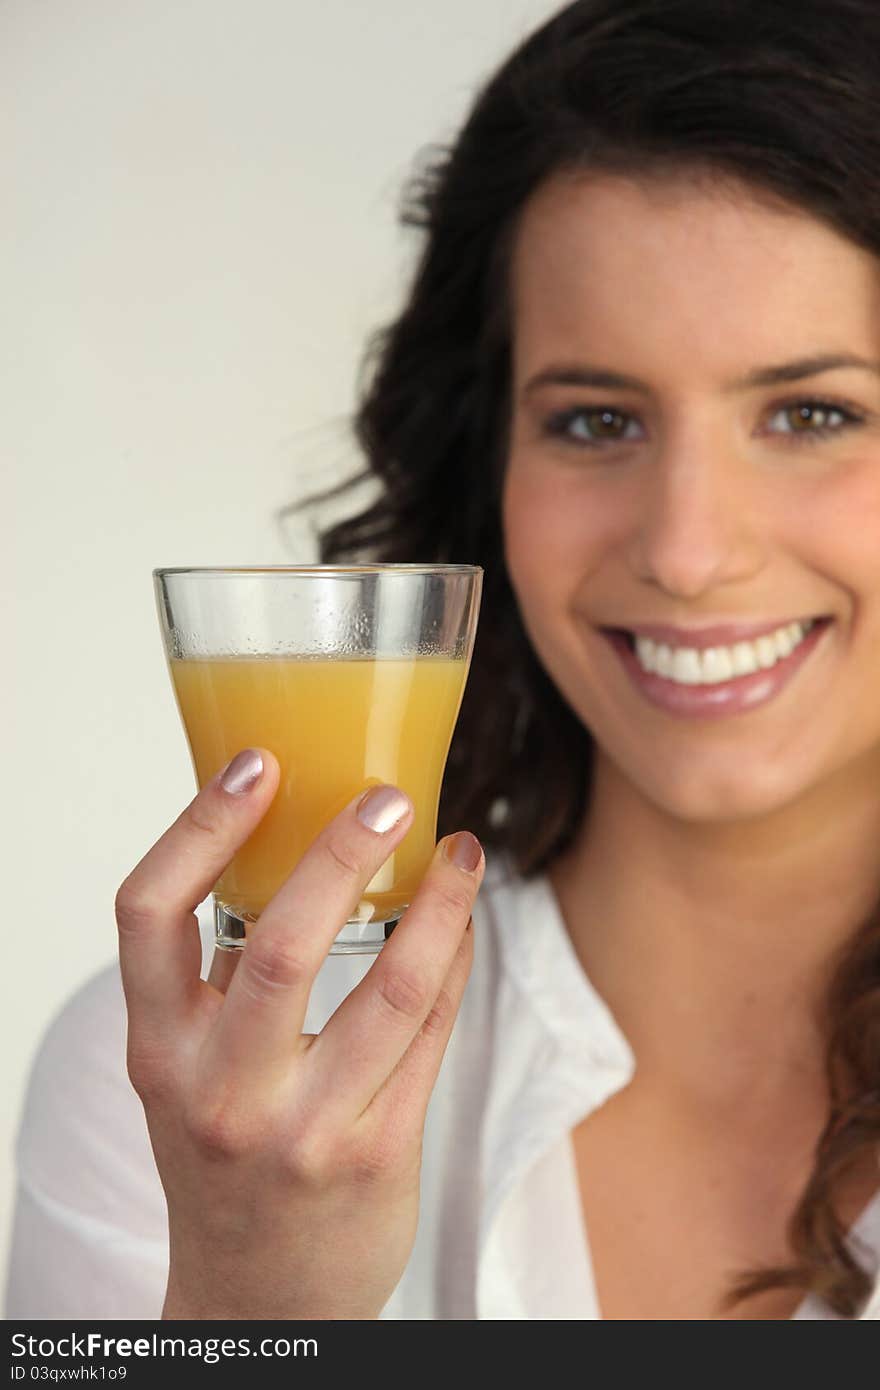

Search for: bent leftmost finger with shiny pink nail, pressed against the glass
xmin=115 ymin=749 xmax=279 ymax=1027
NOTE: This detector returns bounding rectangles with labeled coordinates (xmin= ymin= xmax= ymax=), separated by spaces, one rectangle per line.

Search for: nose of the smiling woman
xmin=628 ymin=427 xmax=766 ymax=599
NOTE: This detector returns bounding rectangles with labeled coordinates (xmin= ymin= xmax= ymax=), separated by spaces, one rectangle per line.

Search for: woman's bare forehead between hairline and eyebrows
xmin=510 ymin=174 xmax=880 ymax=374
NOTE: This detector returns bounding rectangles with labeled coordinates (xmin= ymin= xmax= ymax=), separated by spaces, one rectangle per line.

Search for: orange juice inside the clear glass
xmin=171 ymin=656 xmax=468 ymax=922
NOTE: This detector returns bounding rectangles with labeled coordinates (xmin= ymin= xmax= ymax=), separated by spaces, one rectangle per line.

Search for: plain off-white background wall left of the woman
xmin=0 ymin=0 xmax=560 ymax=1278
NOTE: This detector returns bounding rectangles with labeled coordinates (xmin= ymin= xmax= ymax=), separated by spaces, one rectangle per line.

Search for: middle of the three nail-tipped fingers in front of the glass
xmin=206 ymin=785 xmax=413 ymax=1087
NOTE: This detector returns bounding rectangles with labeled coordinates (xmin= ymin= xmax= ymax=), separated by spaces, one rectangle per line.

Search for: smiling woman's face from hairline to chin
xmin=503 ymin=175 xmax=880 ymax=820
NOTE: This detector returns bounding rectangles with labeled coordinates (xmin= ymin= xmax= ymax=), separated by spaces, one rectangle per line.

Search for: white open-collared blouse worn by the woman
xmin=6 ymin=856 xmax=880 ymax=1319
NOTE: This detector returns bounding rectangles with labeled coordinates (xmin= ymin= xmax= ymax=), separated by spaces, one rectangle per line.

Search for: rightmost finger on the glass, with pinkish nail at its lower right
xmin=300 ymin=831 xmax=485 ymax=1123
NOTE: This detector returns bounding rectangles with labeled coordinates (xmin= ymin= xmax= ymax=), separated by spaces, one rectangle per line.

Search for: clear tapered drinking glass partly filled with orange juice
xmin=153 ymin=564 xmax=482 ymax=955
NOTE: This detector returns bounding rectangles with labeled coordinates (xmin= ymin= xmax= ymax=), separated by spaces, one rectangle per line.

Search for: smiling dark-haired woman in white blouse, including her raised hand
xmin=11 ymin=0 xmax=880 ymax=1319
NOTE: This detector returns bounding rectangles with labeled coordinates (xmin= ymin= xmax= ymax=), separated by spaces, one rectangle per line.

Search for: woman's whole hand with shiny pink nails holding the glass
xmin=115 ymin=749 xmax=484 ymax=1319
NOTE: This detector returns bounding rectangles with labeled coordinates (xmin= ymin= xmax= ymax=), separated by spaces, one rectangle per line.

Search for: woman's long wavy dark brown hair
xmin=291 ymin=0 xmax=880 ymax=1316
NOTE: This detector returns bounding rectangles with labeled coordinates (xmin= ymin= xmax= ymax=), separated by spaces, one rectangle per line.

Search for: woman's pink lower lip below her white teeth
xmin=598 ymin=617 xmax=833 ymax=719
